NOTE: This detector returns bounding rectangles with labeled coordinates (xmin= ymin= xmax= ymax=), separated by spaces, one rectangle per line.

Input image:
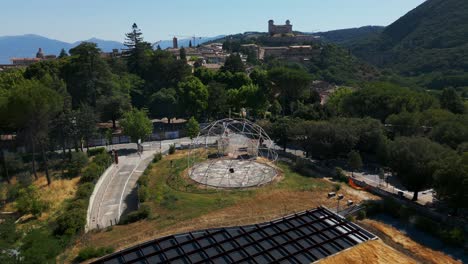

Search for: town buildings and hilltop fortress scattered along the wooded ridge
xmin=0 ymin=20 xmax=320 ymax=70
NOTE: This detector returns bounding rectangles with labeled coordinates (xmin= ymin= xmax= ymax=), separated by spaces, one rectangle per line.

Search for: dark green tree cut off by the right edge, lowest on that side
xmin=434 ymin=152 xmax=468 ymax=212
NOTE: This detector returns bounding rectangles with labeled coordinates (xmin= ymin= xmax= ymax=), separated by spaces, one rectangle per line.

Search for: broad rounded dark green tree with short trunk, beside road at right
xmin=388 ymin=137 xmax=448 ymax=201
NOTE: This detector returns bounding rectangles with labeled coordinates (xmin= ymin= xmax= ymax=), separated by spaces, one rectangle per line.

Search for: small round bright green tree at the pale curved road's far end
xmin=120 ymin=108 xmax=153 ymax=149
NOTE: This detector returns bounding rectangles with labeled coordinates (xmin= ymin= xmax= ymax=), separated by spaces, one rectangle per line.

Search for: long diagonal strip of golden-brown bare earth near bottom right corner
xmin=360 ymin=219 xmax=461 ymax=264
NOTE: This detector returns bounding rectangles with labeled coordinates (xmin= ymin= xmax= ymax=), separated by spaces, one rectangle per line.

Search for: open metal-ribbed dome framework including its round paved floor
xmin=188 ymin=118 xmax=278 ymax=188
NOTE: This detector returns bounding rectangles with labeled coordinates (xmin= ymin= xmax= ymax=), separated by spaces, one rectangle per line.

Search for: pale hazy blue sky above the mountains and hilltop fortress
xmin=0 ymin=0 xmax=424 ymax=42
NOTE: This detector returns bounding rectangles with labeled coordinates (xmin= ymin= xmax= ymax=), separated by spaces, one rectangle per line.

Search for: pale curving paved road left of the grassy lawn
xmin=86 ymin=138 xmax=190 ymax=231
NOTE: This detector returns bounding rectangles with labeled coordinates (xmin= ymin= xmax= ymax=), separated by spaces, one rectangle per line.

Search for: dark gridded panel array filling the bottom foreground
xmin=94 ymin=208 xmax=376 ymax=264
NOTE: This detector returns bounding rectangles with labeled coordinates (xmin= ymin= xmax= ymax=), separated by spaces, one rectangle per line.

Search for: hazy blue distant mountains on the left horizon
xmin=0 ymin=34 xmax=223 ymax=64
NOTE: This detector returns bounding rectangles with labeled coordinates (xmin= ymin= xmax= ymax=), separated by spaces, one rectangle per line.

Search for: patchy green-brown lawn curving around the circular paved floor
xmin=140 ymin=152 xmax=332 ymax=228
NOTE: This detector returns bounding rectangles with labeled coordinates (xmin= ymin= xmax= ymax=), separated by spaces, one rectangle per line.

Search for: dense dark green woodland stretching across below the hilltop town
xmin=0 ymin=16 xmax=468 ymax=263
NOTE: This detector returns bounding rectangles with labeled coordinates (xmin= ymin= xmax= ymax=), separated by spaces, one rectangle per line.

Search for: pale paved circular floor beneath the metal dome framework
xmin=189 ymin=159 xmax=277 ymax=188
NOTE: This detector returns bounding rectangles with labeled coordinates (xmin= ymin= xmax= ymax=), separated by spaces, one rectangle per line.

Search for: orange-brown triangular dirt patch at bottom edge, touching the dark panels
xmin=319 ymin=240 xmax=418 ymax=264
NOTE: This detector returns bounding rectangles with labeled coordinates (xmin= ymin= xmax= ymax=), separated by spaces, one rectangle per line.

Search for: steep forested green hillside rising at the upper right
xmin=348 ymin=0 xmax=468 ymax=83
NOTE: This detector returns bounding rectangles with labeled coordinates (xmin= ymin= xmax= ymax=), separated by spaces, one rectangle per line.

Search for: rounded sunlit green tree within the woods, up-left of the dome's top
xmin=178 ymin=77 xmax=208 ymax=117
